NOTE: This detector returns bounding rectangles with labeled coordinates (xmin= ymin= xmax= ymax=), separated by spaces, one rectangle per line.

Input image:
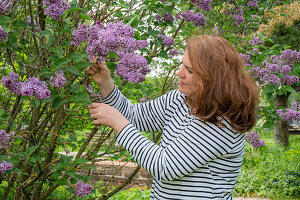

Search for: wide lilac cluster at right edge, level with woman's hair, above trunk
xmin=250 ymin=49 xmax=300 ymax=85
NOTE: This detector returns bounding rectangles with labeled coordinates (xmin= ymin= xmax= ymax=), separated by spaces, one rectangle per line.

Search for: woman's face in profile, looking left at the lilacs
xmin=176 ymin=50 xmax=196 ymax=96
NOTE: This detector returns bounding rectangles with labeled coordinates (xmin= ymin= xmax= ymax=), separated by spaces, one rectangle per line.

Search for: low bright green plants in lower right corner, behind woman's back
xmin=234 ymin=131 xmax=300 ymax=199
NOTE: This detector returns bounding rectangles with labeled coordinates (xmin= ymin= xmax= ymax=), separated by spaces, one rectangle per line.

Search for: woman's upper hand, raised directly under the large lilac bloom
xmin=86 ymin=63 xmax=111 ymax=85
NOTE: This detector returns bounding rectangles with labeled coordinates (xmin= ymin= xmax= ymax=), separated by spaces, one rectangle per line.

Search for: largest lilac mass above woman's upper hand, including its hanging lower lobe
xmin=71 ymin=21 xmax=150 ymax=83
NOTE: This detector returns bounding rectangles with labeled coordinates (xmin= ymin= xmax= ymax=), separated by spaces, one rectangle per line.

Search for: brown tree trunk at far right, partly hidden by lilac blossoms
xmin=274 ymin=95 xmax=289 ymax=147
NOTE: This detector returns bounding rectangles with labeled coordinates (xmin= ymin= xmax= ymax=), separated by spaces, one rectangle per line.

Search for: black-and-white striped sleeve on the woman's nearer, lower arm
xmin=117 ymin=119 xmax=243 ymax=181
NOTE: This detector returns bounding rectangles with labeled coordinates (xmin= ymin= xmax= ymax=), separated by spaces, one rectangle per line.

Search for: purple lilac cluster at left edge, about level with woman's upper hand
xmin=2 ymin=72 xmax=50 ymax=99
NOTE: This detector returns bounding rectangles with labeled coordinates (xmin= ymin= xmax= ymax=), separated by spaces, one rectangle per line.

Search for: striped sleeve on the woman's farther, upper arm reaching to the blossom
xmin=103 ymin=86 xmax=179 ymax=131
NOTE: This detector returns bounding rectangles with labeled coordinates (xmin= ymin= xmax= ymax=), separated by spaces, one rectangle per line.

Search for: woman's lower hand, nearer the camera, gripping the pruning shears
xmin=88 ymin=103 xmax=130 ymax=133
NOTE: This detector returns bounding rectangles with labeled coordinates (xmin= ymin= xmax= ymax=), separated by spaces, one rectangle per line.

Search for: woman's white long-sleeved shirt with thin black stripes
xmin=103 ymin=87 xmax=245 ymax=200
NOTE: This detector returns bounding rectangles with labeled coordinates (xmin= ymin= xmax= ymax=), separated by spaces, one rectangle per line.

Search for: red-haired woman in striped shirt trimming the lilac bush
xmin=87 ymin=35 xmax=258 ymax=200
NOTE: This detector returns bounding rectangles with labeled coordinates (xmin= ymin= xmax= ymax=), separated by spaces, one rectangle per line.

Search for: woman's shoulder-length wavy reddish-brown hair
xmin=186 ymin=35 xmax=259 ymax=133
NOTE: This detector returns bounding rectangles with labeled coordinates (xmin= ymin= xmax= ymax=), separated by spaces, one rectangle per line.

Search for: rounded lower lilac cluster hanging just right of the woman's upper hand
xmin=116 ymin=52 xmax=150 ymax=83
